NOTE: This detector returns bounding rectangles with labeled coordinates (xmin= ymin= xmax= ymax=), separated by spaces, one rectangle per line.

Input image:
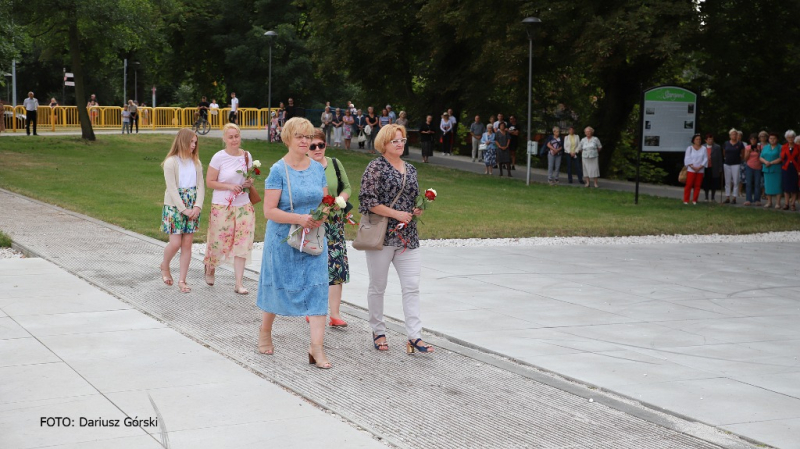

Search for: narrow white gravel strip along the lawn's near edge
xmin=192 ymin=231 xmax=800 ymax=254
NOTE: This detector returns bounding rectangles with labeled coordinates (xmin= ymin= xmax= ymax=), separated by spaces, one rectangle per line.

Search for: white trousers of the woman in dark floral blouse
xmin=366 ymin=246 xmax=422 ymax=340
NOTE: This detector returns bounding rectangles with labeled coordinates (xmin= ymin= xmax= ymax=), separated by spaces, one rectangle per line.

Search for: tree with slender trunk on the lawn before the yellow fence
xmin=11 ymin=0 xmax=164 ymax=140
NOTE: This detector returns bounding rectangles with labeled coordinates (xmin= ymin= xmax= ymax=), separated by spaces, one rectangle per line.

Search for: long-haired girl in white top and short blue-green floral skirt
xmin=161 ymin=128 xmax=205 ymax=293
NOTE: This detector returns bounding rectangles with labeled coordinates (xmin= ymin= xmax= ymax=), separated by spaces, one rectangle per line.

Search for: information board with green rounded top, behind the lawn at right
xmin=641 ymin=86 xmax=697 ymax=153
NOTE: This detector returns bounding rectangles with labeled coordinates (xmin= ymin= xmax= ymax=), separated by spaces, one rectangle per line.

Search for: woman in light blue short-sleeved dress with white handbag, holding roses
xmin=256 ymin=117 xmax=331 ymax=369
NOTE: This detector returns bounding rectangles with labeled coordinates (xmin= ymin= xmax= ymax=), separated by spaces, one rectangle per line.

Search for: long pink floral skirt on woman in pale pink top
xmin=203 ymin=203 xmax=256 ymax=267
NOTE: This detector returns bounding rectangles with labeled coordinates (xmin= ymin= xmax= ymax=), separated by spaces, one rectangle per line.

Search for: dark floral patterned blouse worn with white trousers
xmin=358 ymin=157 xmax=419 ymax=249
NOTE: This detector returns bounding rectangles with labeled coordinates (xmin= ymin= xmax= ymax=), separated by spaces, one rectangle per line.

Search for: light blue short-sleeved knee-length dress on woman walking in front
xmin=256 ymin=159 xmax=328 ymax=316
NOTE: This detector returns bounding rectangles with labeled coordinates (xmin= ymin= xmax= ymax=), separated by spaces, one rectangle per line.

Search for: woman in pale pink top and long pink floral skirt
xmin=203 ymin=123 xmax=256 ymax=295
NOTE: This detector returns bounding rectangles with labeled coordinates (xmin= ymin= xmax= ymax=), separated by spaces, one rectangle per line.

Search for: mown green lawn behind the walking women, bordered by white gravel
xmin=0 ymin=135 xmax=800 ymax=241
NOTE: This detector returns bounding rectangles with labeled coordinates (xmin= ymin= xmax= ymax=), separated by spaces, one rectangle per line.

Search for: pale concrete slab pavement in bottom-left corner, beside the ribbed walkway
xmin=0 ymin=258 xmax=386 ymax=449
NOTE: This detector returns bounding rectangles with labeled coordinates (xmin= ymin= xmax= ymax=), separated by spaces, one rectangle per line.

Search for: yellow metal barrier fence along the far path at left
xmin=2 ymin=105 xmax=277 ymax=132
